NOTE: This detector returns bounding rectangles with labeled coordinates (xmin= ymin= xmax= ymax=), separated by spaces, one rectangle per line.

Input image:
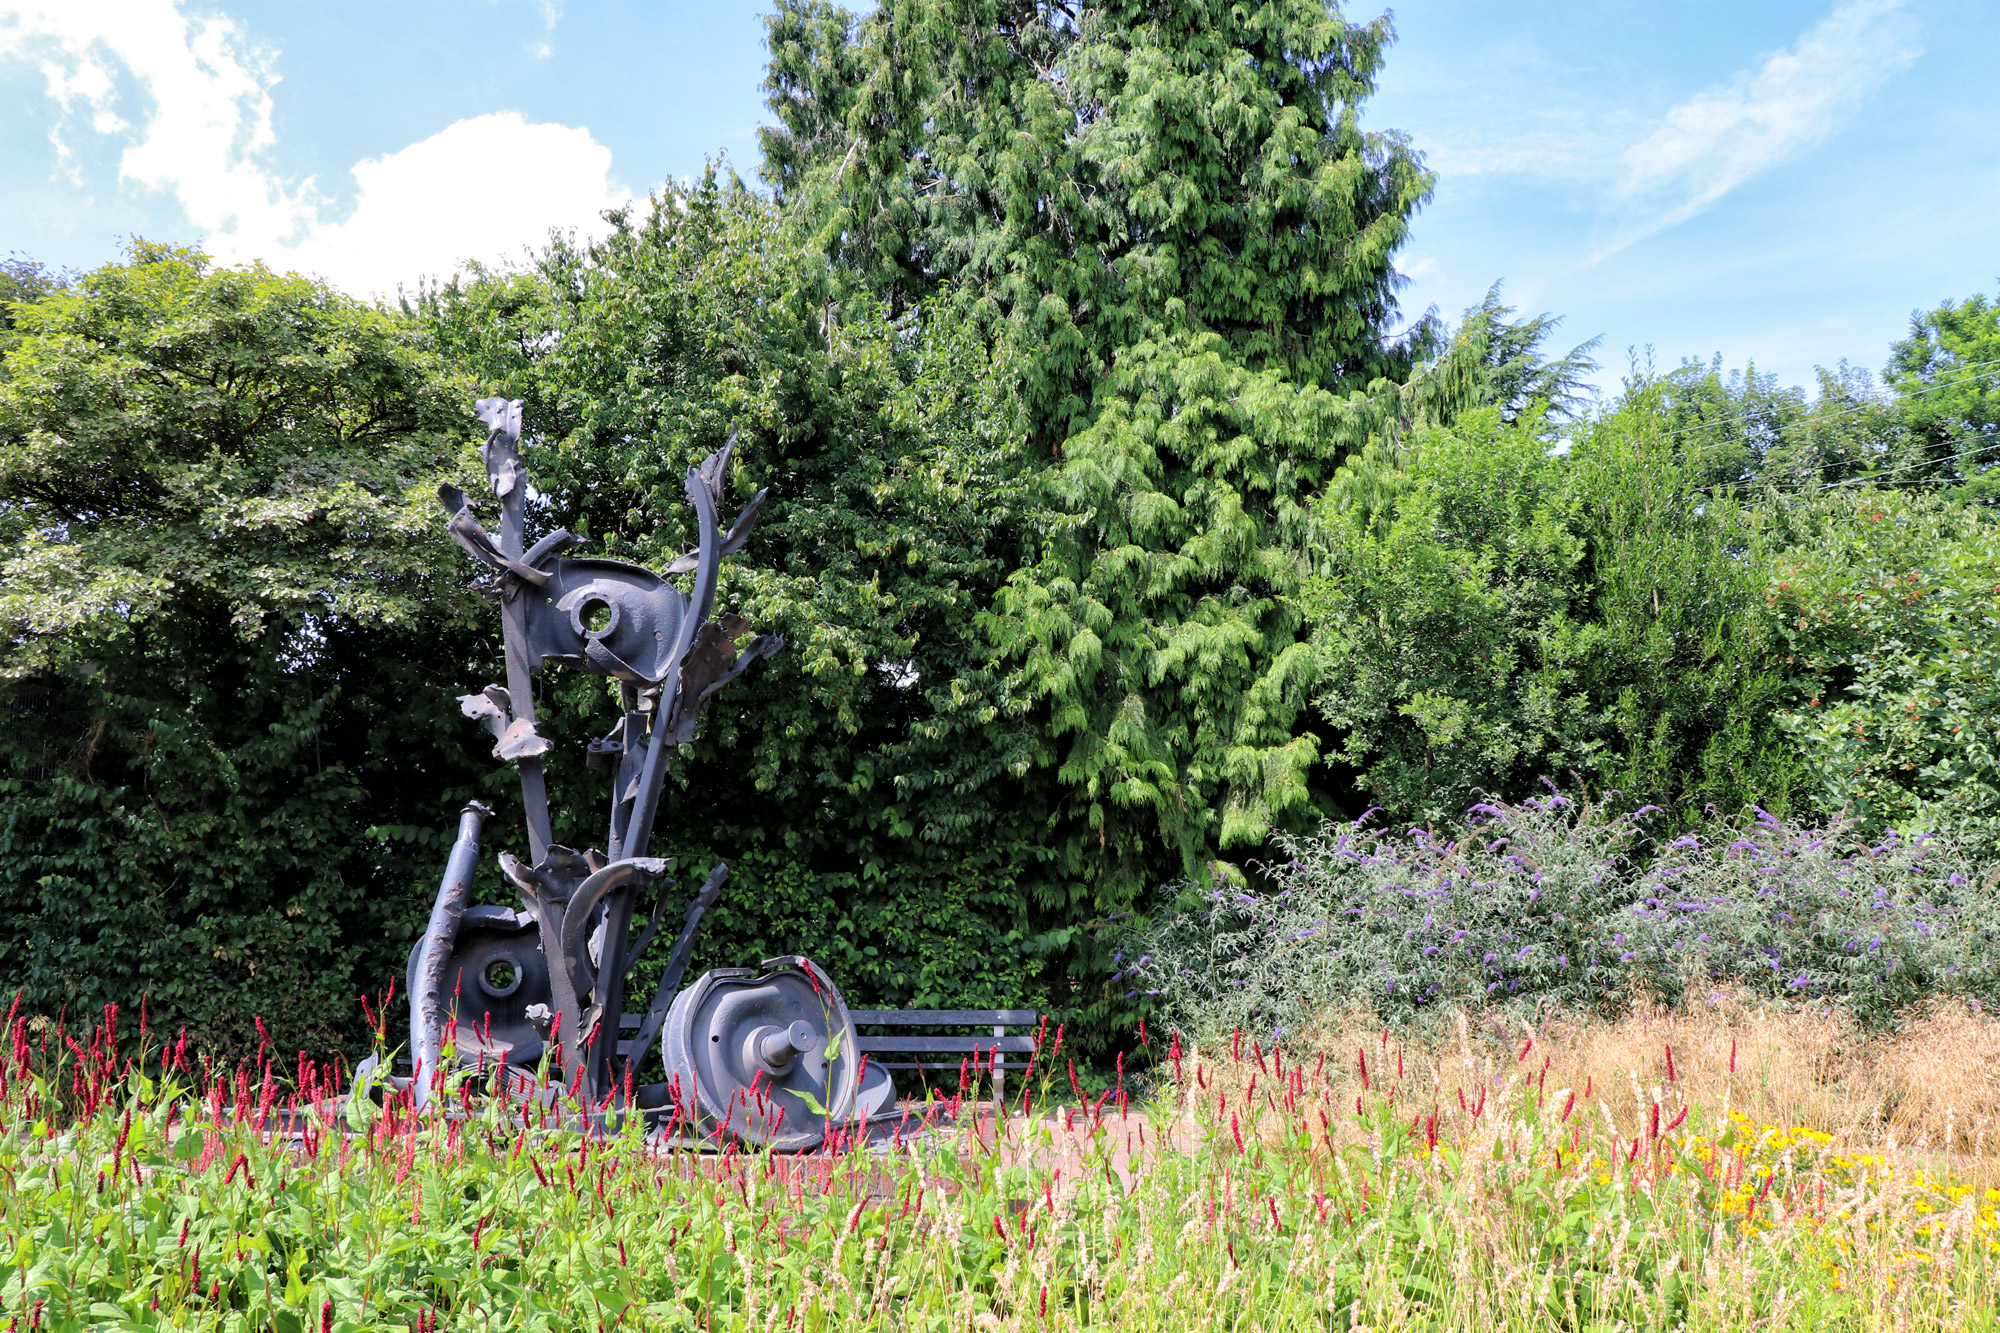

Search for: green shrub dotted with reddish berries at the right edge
xmin=1766 ymin=490 xmax=2000 ymax=851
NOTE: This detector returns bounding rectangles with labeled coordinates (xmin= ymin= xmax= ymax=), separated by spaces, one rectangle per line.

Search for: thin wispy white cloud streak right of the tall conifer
xmin=1612 ymin=0 xmax=1920 ymax=250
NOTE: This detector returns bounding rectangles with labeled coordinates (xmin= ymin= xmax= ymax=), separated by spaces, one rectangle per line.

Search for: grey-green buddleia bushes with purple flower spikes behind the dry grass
xmin=1122 ymin=791 xmax=2000 ymax=1041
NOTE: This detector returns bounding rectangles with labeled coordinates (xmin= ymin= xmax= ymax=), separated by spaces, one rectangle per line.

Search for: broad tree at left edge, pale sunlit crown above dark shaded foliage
xmin=0 ymin=244 xmax=488 ymax=1047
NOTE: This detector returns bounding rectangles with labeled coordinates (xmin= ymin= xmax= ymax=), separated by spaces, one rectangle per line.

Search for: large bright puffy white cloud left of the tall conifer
xmin=0 ymin=0 xmax=630 ymax=294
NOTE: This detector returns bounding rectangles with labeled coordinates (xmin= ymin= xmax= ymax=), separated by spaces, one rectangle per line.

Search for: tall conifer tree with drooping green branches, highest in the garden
xmin=764 ymin=0 xmax=1476 ymax=948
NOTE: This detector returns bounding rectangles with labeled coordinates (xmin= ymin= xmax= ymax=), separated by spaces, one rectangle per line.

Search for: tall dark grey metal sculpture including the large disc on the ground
xmin=408 ymin=398 xmax=886 ymax=1149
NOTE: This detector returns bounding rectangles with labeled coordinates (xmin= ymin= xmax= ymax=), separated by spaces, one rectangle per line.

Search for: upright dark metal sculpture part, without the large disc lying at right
xmin=410 ymin=398 xmax=784 ymax=1107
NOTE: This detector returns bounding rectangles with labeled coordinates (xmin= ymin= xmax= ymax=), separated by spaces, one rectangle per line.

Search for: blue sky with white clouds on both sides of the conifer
xmin=0 ymin=0 xmax=2000 ymax=384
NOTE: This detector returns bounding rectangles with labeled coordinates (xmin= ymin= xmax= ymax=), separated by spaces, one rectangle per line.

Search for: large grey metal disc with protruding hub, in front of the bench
xmin=660 ymin=957 xmax=862 ymax=1151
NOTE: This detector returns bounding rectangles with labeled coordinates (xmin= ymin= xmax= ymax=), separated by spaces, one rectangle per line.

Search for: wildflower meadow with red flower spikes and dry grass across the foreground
xmin=0 ymin=980 xmax=2000 ymax=1333
